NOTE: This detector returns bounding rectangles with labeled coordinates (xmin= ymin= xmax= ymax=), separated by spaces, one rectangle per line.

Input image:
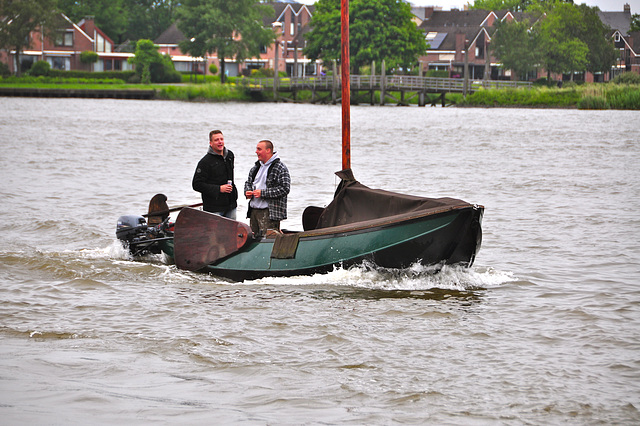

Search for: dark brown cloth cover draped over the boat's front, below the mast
xmin=316 ymin=170 xmax=470 ymax=229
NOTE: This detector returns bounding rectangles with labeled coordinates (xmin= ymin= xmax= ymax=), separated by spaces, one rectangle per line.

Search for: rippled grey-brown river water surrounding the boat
xmin=0 ymin=98 xmax=640 ymax=425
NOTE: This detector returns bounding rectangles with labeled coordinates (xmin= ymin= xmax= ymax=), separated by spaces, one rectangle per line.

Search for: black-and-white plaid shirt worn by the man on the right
xmin=244 ymin=158 xmax=291 ymax=220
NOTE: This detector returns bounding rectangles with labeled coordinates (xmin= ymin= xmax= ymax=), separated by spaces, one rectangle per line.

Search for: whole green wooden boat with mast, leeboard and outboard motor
xmin=116 ymin=0 xmax=484 ymax=281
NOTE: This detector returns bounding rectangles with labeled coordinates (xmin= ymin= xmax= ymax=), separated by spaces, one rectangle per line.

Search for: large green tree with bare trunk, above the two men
xmin=177 ymin=0 xmax=275 ymax=83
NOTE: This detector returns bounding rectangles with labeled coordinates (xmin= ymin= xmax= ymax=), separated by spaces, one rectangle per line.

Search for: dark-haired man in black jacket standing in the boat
xmin=192 ymin=130 xmax=238 ymax=220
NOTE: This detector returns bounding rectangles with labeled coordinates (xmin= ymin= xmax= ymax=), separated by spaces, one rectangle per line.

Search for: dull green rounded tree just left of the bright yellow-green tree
xmin=491 ymin=20 xmax=540 ymax=78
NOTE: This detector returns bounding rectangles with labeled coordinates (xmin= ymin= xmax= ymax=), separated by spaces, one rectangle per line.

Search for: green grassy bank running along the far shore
xmin=0 ymin=76 xmax=640 ymax=110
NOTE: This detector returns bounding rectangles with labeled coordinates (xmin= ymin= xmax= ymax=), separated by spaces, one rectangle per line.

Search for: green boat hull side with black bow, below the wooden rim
xmin=163 ymin=205 xmax=484 ymax=281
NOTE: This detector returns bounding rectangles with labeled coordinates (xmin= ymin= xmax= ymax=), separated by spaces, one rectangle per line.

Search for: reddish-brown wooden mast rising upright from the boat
xmin=340 ymin=0 xmax=351 ymax=170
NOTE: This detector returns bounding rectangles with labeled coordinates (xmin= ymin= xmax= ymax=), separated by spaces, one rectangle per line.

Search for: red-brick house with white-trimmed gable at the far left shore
xmin=0 ymin=14 xmax=133 ymax=72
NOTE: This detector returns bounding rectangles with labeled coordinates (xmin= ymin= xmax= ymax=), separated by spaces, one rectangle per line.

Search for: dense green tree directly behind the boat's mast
xmin=304 ymin=0 xmax=427 ymax=74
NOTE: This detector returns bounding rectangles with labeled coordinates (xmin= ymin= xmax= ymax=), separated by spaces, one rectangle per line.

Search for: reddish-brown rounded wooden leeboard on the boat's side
xmin=173 ymin=207 xmax=253 ymax=271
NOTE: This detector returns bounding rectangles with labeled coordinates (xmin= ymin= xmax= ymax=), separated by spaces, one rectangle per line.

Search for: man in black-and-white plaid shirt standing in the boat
xmin=244 ymin=140 xmax=291 ymax=236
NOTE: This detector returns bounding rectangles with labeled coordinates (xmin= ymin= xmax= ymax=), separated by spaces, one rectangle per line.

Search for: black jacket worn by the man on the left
xmin=192 ymin=148 xmax=238 ymax=212
